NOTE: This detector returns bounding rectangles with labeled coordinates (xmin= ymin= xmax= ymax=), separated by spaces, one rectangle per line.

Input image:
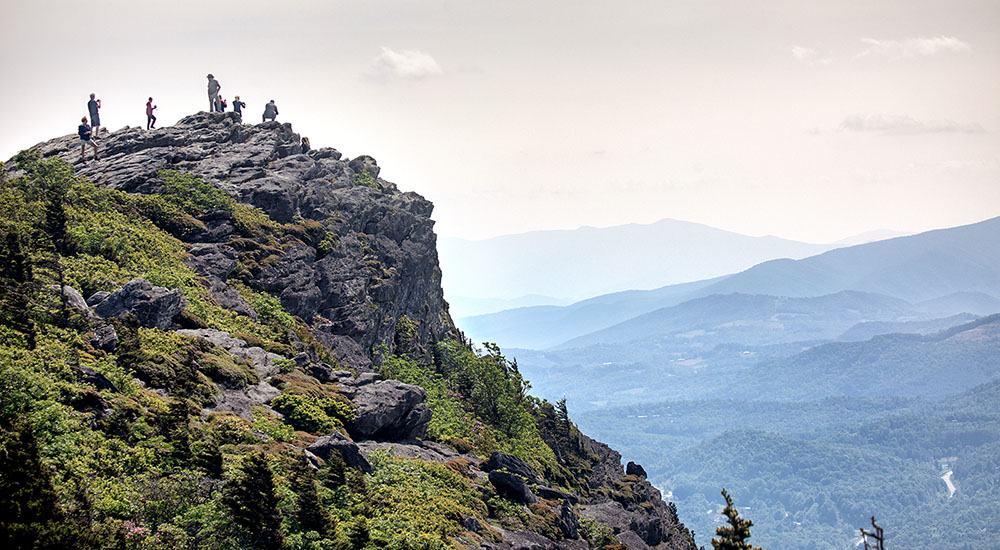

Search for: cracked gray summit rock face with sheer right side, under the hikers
xmin=26 ymin=113 xmax=455 ymax=370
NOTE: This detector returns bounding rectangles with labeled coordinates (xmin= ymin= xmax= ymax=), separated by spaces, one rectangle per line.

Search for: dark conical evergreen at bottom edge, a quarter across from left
xmin=222 ymin=451 xmax=284 ymax=550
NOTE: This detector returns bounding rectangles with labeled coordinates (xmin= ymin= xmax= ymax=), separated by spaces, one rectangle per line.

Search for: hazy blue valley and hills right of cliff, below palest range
xmin=458 ymin=220 xmax=1000 ymax=550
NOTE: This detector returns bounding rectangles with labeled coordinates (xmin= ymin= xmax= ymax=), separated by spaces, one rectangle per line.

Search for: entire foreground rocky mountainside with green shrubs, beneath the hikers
xmin=0 ymin=113 xmax=694 ymax=550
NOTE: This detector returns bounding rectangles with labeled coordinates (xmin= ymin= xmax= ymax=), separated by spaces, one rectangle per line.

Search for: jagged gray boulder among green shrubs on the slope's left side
xmin=94 ymin=278 xmax=187 ymax=330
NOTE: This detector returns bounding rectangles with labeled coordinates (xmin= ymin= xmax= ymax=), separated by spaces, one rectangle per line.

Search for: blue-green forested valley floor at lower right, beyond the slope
xmin=581 ymin=381 xmax=1000 ymax=549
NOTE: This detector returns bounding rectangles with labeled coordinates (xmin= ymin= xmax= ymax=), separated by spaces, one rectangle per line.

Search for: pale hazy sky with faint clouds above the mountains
xmin=0 ymin=0 xmax=1000 ymax=241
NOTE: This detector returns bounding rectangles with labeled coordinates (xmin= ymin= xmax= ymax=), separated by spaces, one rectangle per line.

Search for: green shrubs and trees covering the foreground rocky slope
xmin=0 ymin=152 xmax=608 ymax=550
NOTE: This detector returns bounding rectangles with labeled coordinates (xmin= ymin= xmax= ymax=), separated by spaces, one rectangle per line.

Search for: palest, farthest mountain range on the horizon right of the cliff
xmin=439 ymin=219 xmax=833 ymax=306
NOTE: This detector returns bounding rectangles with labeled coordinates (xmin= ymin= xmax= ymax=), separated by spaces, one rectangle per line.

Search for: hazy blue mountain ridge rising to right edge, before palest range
xmin=459 ymin=217 xmax=1000 ymax=349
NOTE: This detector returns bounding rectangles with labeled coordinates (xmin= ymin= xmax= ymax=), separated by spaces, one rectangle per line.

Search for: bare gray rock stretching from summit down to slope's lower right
xmin=21 ymin=113 xmax=695 ymax=550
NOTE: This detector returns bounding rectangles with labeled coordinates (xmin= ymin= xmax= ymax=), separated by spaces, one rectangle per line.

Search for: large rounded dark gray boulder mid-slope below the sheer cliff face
xmin=349 ymin=380 xmax=431 ymax=441
